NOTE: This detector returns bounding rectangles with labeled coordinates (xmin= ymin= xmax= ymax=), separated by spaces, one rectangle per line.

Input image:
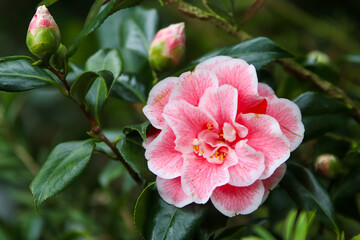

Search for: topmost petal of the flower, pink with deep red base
xmin=212 ymin=59 xmax=258 ymax=110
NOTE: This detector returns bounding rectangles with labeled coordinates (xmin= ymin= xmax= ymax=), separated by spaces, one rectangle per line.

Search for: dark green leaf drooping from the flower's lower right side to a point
xmin=281 ymin=163 xmax=339 ymax=234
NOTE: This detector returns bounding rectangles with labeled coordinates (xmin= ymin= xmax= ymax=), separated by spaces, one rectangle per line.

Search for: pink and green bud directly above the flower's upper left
xmin=149 ymin=23 xmax=185 ymax=72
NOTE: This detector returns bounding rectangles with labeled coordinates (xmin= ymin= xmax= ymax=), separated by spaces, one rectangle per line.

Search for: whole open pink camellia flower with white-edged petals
xmin=143 ymin=56 xmax=304 ymax=217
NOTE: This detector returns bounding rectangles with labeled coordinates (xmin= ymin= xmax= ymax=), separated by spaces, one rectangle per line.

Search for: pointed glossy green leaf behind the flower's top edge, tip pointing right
xmin=186 ymin=37 xmax=292 ymax=70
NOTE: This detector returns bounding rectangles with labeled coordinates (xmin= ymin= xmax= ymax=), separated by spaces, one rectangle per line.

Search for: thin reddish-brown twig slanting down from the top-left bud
xmin=48 ymin=66 xmax=142 ymax=185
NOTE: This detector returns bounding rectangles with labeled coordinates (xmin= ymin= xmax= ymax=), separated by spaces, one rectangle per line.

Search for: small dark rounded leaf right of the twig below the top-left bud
xmin=70 ymin=72 xmax=99 ymax=103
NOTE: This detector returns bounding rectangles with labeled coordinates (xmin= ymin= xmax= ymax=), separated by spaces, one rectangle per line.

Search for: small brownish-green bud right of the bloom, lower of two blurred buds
xmin=315 ymin=153 xmax=341 ymax=178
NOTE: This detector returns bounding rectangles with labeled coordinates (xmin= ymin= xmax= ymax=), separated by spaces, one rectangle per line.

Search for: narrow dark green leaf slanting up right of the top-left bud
xmin=67 ymin=0 xmax=116 ymax=58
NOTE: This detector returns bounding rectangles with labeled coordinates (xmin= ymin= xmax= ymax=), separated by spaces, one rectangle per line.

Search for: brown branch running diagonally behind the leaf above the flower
xmin=165 ymin=0 xmax=360 ymax=123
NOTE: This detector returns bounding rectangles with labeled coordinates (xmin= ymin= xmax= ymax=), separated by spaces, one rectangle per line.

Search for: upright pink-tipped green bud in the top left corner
xmin=26 ymin=6 xmax=60 ymax=59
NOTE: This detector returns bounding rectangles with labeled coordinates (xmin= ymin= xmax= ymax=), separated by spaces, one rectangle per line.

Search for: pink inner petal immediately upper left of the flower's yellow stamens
xmin=163 ymin=100 xmax=218 ymax=153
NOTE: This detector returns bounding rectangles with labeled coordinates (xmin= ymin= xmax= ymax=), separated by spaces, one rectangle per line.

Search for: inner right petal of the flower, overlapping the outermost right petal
xmin=237 ymin=113 xmax=290 ymax=179
